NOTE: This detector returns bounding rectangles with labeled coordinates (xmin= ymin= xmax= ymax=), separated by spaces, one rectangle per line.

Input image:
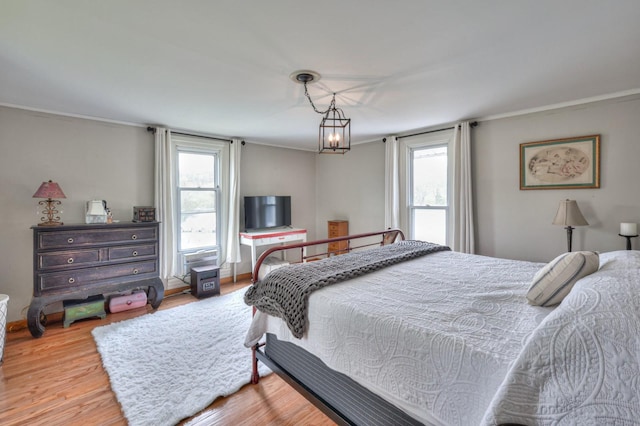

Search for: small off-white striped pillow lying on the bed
xmin=527 ymin=251 xmax=600 ymax=306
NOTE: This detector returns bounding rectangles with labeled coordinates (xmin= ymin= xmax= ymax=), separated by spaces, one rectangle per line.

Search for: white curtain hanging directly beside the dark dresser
xmin=154 ymin=127 xmax=177 ymax=280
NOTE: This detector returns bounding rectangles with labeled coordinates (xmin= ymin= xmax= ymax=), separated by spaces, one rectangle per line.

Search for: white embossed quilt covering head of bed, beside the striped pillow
xmin=484 ymin=250 xmax=640 ymax=426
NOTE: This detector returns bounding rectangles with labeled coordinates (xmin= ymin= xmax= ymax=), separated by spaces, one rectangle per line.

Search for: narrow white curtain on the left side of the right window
xmin=384 ymin=136 xmax=400 ymax=229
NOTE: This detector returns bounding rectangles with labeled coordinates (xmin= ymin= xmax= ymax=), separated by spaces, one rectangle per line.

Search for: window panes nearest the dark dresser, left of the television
xmin=177 ymin=148 xmax=220 ymax=252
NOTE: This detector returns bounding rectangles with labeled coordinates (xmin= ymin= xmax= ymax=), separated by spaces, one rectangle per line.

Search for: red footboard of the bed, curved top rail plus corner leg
xmin=251 ymin=228 xmax=404 ymax=384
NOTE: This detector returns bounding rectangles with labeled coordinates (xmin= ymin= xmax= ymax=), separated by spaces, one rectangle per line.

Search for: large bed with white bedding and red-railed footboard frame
xmin=245 ymin=231 xmax=640 ymax=426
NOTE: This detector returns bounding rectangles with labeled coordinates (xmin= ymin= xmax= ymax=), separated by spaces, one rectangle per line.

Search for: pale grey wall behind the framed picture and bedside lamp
xmin=472 ymin=96 xmax=640 ymax=261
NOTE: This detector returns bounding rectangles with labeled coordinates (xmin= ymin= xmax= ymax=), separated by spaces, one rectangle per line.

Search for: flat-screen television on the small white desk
xmin=244 ymin=195 xmax=291 ymax=231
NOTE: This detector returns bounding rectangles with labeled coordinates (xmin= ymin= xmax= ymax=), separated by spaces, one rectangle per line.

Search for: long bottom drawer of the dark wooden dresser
xmin=34 ymin=260 xmax=158 ymax=296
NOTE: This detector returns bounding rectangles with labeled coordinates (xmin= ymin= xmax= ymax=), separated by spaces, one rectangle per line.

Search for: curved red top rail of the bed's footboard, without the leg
xmin=251 ymin=228 xmax=404 ymax=283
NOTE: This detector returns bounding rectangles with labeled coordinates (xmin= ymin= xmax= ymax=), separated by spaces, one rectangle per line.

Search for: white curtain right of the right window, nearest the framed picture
xmin=452 ymin=121 xmax=475 ymax=253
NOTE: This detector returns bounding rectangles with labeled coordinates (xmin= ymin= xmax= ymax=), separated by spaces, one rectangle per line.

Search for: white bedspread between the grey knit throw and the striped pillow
xmin=247 ymin=252 xmax=551 ymax=426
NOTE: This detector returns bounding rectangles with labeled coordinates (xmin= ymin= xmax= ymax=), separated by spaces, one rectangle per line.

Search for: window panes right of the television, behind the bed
xmin=409 ymin=145 xmax=449 ymax=244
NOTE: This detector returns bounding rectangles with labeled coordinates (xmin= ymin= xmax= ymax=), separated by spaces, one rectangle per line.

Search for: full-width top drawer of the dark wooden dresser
xmin=37 ymin=227 xmax=157 ymax=250
